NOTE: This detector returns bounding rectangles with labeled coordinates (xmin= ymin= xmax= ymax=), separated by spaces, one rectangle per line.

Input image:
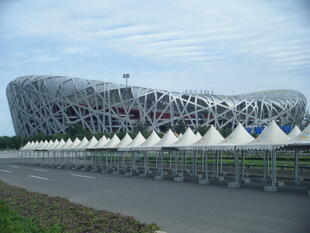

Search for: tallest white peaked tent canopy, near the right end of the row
xmin=239 ymin=120 xmax=290 ymax=150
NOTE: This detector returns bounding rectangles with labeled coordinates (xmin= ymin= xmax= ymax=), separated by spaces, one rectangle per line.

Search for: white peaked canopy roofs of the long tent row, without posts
xmin=20 ymin=121 xmax=310 ymax=151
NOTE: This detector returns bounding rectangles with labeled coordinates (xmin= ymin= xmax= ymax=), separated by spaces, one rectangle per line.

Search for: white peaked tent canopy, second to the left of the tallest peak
xmin=186 ymin=125 xmax=224 ymax=149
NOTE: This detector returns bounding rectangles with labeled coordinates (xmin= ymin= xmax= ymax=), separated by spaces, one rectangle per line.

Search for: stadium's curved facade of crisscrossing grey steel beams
xmin=7 ymin=75 xmax=306 ymax=136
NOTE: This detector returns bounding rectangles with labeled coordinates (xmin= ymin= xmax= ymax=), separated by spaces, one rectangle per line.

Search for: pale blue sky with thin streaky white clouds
xmin=0 ymin=0 xmax=310 ymax=136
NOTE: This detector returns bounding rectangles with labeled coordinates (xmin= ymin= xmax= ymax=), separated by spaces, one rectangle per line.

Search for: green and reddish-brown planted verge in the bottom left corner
xmin=0 ymin=181 xmax=159 ymax=233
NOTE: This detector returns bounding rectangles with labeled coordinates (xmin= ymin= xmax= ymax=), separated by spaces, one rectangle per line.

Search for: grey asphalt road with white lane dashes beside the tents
xmin=0 ymin=159 xmax=310 ymax=233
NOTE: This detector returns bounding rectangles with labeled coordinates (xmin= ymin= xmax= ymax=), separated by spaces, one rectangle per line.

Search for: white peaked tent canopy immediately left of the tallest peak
xmin=206 ymin=123 xmax=254 ymax=150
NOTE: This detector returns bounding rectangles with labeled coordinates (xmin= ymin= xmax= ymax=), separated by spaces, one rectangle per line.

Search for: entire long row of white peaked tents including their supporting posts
xmin=16 ymin=121 xmax=310 ymax=195
